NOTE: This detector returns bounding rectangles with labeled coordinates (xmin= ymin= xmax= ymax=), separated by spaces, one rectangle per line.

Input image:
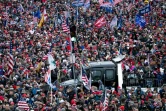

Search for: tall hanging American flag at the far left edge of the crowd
xmin=7 ymin=41 xmax=14 ymax=75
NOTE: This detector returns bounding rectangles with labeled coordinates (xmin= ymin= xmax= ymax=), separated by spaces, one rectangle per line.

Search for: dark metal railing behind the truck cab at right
xmin=123 ymin=78 xmax=163 ymax=88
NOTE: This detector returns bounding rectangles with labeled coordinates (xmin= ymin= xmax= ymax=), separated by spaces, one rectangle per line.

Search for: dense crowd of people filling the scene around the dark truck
xmin=0 ymin=0 xmax=166 ymax=111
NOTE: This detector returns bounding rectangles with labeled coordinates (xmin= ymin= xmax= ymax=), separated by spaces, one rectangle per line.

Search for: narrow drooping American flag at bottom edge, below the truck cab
xmin=101 ymin=89 xmax=109 ymax=111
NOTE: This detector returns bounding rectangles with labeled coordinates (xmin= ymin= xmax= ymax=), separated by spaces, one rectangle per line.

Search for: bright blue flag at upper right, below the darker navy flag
xmin=135 ymin=14 xmax=146 ymax=27
